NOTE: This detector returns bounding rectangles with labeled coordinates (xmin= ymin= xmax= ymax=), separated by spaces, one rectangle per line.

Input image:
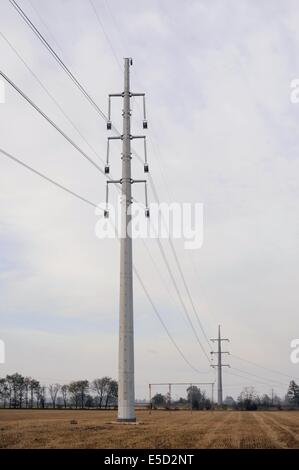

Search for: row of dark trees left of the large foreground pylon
xmin=0 ymin=373 xmax=118 ymax=409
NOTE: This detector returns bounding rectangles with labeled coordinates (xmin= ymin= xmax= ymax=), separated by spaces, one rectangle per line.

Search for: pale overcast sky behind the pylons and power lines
xmin=0 ymin=0 xmax=299 ymax=398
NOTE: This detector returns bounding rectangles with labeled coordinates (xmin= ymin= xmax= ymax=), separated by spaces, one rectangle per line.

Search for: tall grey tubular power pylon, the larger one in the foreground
xmin=104 ymin=58 xmax=150 ymax=422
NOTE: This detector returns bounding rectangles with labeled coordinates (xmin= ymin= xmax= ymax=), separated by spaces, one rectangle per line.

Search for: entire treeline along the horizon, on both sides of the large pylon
xmin=0 ymin=373 xmax=299 ymax=410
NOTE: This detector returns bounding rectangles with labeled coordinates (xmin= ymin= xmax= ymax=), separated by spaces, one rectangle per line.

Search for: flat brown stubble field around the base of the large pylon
xmin=0 ymin=410 xmax=299 ymax=449
